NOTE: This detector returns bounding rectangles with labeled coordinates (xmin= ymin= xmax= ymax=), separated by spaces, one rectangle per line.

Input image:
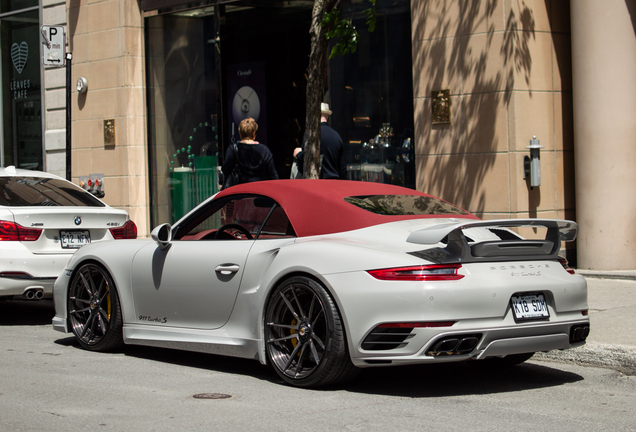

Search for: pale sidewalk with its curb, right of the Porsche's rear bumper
xmin=533 ymin=270 xmax=636 ymax=375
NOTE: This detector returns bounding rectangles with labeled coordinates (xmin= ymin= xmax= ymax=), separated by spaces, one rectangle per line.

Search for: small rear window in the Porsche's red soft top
xmin=344 ymin=195 xmax=470 ymax=216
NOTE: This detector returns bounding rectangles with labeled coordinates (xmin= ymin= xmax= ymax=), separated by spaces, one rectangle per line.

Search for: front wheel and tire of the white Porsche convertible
xmin=67 ymin=263 xmax=124 ymax=351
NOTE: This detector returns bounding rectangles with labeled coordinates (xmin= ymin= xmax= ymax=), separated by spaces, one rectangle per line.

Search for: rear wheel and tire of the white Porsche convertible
xmin=265 ymin=277 xmax=358 ymax=388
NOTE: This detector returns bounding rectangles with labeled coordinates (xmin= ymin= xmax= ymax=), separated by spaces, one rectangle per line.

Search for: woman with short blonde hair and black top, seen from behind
xmin=221 ymin=117 xmax=278 ymax=189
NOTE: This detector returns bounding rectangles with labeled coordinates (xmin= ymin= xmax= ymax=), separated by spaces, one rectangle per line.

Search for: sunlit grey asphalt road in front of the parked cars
xmin=0 ymin=302 xmax=636 ymax=432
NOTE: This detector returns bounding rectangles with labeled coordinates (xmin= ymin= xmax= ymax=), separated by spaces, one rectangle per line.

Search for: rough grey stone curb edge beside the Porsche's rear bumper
xmin=532 ymin=342 xmax=636 ymax=375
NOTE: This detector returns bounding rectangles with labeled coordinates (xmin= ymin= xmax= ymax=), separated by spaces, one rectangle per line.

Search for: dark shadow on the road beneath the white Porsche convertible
xmin=55 ymin=338 xmax=583 ymax=398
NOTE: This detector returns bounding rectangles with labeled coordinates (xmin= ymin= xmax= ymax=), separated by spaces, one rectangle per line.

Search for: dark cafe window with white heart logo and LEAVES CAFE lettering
xmin=0 ymin=8 xmax=43 ymax=170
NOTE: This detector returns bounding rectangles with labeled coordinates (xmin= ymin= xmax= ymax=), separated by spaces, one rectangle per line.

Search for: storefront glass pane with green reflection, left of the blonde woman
xmin=146 ymin=8 xmax=219 ymax=224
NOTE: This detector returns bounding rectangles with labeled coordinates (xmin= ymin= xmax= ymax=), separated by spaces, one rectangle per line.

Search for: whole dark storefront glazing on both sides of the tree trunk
xmin=145 ymin=0 xmax=415 ymax=226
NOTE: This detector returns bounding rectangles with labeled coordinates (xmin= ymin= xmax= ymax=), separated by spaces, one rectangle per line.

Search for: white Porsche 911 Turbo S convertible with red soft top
xmin=53 ymin=180 xmax=589 ymax=387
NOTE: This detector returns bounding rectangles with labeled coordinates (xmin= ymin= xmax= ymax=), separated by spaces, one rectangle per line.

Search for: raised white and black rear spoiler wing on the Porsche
xmin=406 ymin=219 xmax=578 ymax=264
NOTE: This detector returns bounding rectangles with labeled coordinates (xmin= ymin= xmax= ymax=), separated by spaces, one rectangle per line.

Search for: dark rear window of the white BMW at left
xmin=0 ymin=177 xmax=105 ymax=207
